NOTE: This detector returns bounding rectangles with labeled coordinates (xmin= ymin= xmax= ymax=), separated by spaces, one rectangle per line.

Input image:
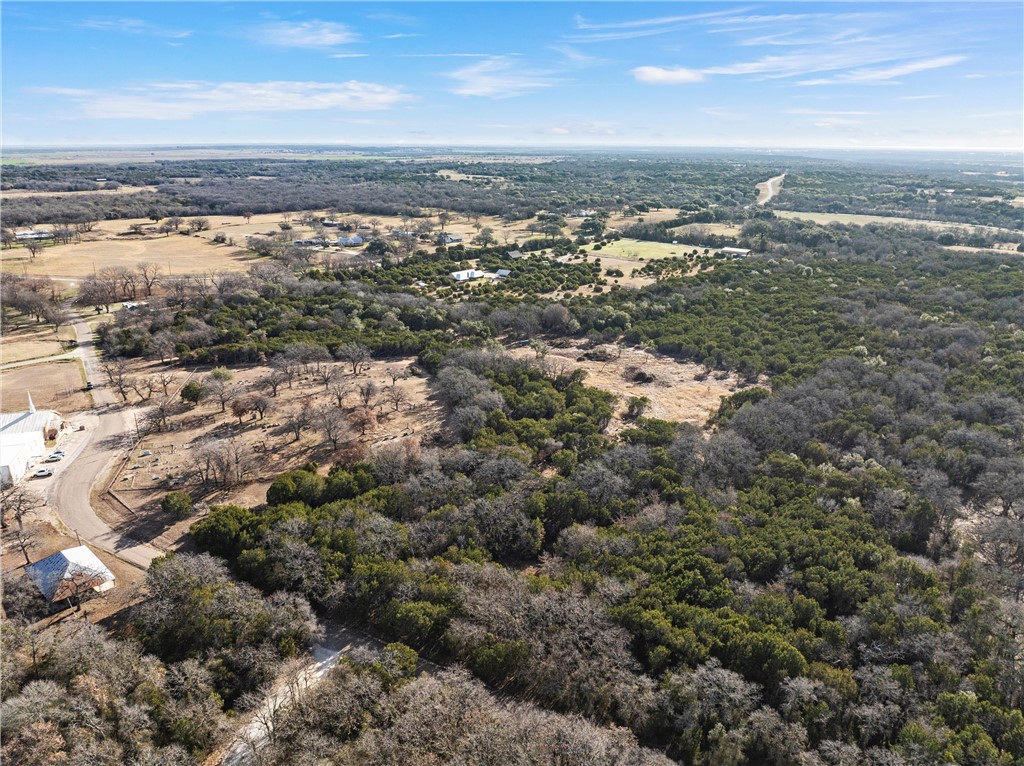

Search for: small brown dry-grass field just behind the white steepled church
xmin=0 ymin=358 xmax=92 ymax=416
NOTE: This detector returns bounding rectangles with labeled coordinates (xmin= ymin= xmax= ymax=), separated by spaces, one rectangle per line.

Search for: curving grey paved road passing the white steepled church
xmin=36 ymin=320 xmax=164 ymax=568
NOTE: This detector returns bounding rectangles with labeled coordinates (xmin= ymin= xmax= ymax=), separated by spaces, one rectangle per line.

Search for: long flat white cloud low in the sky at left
xmin=31 ymin=80 xmax=412 ymax=120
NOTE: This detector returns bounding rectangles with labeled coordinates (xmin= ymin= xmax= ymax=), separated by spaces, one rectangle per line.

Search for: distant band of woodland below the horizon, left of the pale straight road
xmin=3 ymin=157 xmax=773 ymax=226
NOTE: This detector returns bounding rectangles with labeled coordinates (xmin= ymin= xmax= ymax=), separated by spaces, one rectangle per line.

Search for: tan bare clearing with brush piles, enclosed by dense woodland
xmin=511 ymin=343 xmax=744 ymax=434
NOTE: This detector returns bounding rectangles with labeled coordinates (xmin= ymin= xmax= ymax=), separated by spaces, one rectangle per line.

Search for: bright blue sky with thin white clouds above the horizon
xmin=0 ymin=0 xmax=1024 ymax=151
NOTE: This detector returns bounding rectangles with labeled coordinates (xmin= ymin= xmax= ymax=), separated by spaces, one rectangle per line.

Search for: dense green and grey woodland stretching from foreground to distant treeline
xmin=3 ymin=155 xmax=1024 ymax=766
